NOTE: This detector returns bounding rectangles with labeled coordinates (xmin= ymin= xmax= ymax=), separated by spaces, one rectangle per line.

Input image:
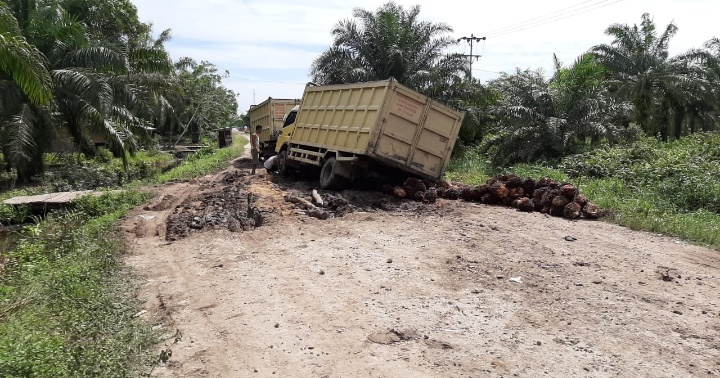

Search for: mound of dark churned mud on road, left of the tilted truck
xmin=165 ymin=180 xmax=265 ymax=241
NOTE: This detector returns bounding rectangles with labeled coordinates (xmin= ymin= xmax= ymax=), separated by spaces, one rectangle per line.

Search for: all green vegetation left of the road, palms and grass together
xmin=0 ymin=0 xmax=245 ymax=377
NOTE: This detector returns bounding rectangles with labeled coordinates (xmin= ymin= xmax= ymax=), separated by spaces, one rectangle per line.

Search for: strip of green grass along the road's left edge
xmin=0 ymin=137 xmax=246 ymax=377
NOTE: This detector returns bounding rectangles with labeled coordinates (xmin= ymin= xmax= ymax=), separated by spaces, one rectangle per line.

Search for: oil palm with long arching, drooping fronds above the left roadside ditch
xmin=52 ymin=29 xmax=177 ymax=158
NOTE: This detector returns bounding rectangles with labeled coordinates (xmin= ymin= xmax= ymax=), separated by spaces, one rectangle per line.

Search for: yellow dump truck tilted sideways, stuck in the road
xmin=276 ymin=79 xmax=465 ymax=189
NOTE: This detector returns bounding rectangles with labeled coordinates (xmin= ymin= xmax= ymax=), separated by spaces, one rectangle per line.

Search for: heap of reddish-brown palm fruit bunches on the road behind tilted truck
xmin=383 ymin=174 xmax=601 ymax=219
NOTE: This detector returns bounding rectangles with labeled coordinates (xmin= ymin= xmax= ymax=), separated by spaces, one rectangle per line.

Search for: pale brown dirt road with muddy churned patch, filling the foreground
xmin=124 ymin=141 xmax=720 ymax=378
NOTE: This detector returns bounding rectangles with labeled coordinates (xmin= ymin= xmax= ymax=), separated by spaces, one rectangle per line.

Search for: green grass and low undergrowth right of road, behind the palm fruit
xmin=446 ymin=133 xmax=720 ymax=250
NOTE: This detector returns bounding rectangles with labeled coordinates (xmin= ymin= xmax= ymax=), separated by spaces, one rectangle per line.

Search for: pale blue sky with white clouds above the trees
xmin=133 ymin=0 xmax=720 ymax=112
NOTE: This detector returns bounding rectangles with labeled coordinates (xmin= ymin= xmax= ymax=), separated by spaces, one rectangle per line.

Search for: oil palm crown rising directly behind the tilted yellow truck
xmin=311 ymin=2 xmax=468 ymax=94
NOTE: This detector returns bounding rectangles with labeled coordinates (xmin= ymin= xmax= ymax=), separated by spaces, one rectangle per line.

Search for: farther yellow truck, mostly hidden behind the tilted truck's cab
xmin=248 ymin=97 xmax=300 ymax=156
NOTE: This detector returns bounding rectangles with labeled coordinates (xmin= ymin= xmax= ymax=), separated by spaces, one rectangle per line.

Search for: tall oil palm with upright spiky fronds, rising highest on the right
xmin=590 ymin=13 xmax=713 ymax=140
